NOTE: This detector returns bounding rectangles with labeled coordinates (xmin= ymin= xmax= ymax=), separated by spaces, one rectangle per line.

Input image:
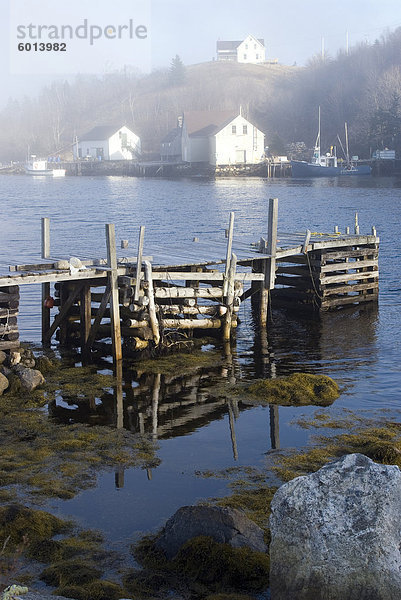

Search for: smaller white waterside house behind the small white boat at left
xmin=74 ymin=125 xmax=141 ymax=160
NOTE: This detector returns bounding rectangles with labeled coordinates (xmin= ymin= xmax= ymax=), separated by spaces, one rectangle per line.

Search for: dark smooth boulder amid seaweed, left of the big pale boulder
xmin=156 ymin=506 xmax=267 ymax=559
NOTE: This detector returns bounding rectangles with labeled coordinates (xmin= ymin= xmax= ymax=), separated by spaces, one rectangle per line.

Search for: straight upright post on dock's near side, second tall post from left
xmin=106 ymin=223 xmax=122 ymax=362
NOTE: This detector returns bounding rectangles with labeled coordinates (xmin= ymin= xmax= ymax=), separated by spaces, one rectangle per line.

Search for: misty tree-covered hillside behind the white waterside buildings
xmin=0 ymin=28 xmax=401 ymax=161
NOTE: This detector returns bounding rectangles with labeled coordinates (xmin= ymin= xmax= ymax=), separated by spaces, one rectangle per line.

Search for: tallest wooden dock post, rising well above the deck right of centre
xmin=260 ymin=198 xmax=278 ymax=326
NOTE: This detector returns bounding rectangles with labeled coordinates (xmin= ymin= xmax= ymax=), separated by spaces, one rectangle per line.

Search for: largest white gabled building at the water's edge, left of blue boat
xmin=161 ymin=110 xmax=265 ymax=166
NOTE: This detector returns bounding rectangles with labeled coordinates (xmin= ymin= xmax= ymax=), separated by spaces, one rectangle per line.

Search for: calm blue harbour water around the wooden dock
xmin=0 ymin=176 xmax=401 ymax=543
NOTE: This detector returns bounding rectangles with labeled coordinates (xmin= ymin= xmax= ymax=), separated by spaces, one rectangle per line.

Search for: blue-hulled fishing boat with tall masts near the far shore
xmin=291 ymin=107 xmax=371 ymax=177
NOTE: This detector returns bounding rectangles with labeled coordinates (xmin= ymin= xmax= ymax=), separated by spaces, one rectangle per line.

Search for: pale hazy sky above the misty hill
xmin=0 ymin=0 xmax=401 ymax=107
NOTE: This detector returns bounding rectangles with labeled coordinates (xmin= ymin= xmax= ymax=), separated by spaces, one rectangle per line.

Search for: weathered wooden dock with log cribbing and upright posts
xmin=0 ymin=199 xmax=379 ymax=361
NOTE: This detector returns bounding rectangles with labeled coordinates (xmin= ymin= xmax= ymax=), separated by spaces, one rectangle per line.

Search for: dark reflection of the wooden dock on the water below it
xmin=48 ymin=305 xmax=378 ymax=468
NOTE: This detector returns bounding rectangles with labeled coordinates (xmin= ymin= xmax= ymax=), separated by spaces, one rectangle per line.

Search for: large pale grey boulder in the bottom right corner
xmin=270 ymin=454 xmax=401 ymax=600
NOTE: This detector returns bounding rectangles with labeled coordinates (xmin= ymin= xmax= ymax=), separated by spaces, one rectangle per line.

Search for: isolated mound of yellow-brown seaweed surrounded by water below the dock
xmin=245 ymin=373 xmax=340 ymax=406
